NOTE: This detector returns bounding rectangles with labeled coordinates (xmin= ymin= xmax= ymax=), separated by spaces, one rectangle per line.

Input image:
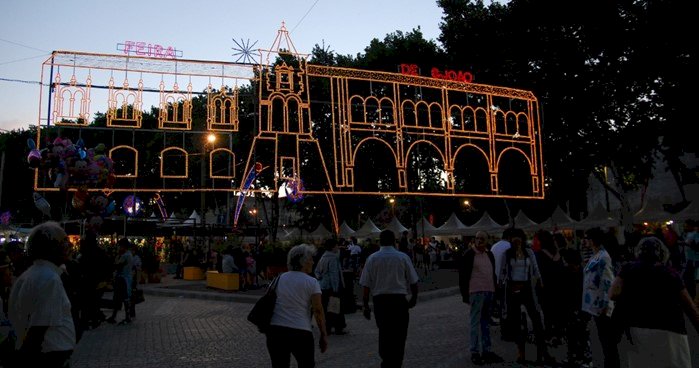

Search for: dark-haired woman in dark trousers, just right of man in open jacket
xmin=500 ymin=229 xmax=554 ymax=364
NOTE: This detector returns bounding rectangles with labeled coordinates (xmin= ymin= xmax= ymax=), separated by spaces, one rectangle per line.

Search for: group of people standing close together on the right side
xmin=458 ymin=221 xmax=699 ymax=367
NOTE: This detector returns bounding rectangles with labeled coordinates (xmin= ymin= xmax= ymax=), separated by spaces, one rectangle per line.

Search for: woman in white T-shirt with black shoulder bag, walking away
xmin=266 ymin=244 xmax=328 ymax=368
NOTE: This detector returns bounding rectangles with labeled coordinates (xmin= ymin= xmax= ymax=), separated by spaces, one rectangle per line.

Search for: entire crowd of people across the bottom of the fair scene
xmin=0 ymin=221 xmax=699 ymax=367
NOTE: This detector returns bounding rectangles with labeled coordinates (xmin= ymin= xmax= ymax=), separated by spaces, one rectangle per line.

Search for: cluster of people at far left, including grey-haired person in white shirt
xmin=0 ymin=221 xmax=148 ymax=367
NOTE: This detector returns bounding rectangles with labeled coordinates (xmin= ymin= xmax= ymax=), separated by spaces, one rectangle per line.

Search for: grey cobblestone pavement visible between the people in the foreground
xmin=71 ymin=272 xmax=699 ymax=368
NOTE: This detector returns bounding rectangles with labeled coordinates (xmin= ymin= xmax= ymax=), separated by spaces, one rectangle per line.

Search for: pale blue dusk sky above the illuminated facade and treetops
xmin=0 ymin=0 xmax=442 ymax=129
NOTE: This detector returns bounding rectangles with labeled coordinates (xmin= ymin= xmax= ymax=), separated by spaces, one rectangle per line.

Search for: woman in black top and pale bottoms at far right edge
xmin=609 ymin=237 xmax=699 ymax=367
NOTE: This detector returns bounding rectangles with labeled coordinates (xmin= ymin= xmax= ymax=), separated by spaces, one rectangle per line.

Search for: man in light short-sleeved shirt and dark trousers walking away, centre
xmin=359 ymin=230 xmax=419 ymax=367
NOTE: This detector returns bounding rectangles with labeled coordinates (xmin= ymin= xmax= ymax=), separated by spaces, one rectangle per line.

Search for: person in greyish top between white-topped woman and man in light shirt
xmin=315 ymin=239 xmax=347 ymax=335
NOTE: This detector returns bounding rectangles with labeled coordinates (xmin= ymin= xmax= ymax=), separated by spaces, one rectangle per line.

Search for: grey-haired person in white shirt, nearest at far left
xmin=8 ymin=221 xmax=76 ymax=367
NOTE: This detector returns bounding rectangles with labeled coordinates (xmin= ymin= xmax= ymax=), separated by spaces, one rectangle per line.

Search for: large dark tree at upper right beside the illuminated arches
xmin=439 ymin=0 xmax=696 ymax=227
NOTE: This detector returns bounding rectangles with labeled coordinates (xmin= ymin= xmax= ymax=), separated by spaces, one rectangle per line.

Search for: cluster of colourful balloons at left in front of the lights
xmin=27 ymin=137 xmax=116 ymax=189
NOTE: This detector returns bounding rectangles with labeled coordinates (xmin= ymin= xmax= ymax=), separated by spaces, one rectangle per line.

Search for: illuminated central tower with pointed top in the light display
xmin=241 ymin=23 xmax=332 ymax=211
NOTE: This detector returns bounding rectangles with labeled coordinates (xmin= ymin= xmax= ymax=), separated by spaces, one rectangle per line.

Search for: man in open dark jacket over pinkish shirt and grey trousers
xmin=459 ymin=231 xmax=503 ymax=365
